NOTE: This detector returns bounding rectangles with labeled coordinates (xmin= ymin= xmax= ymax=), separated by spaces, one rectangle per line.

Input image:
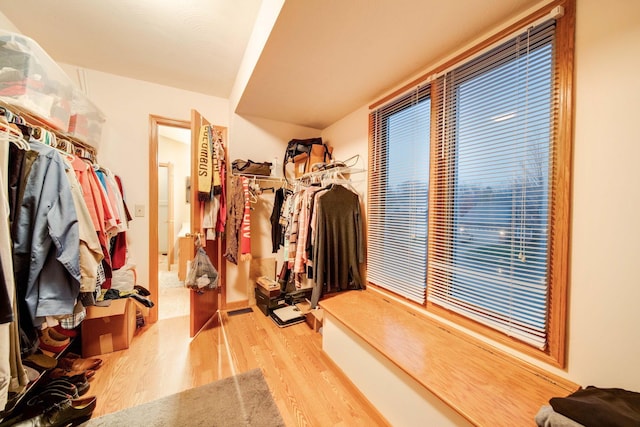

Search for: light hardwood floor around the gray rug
xmin=84 ymin=307 xmax=388 ymax=426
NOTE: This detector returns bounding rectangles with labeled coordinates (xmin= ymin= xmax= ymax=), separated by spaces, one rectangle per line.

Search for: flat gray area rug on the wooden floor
xmin=81 ymin=369 xmax=284 ymax=427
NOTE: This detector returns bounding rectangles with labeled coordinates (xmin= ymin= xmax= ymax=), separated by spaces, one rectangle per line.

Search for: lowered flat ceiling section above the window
xmin=237 ymin=0 xmax=540 ymax=129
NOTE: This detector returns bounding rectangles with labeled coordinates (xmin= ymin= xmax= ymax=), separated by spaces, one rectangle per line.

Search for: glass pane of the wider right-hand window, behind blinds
xmin=451 ymin=46 xmax=551 ymax=327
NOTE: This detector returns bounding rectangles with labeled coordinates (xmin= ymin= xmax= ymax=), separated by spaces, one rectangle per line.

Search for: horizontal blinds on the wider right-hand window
xmin=428 ymin=21 xmax=558 ymax=348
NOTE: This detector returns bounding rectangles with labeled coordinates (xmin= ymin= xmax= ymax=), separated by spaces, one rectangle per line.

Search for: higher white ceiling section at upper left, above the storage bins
xmin=0 ymin=0 xmax=260 ymax=98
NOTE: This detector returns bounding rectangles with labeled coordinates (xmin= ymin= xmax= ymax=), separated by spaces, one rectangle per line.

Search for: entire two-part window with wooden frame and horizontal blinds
xmin=367 ymin=0 xmax=575 ymax=366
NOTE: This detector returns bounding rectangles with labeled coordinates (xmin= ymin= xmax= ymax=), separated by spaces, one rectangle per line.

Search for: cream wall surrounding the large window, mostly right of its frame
xmin=322 ymin=0 xmax=640 ymax=392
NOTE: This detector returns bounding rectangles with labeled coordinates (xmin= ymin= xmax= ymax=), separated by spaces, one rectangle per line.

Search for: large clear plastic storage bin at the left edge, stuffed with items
xmin=0 ymin=31 xmax=73 ymax=132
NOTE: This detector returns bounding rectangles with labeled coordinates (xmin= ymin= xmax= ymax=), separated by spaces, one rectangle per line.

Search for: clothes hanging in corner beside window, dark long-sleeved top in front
xmin=271 ymin=183 xmax=364 ymax=307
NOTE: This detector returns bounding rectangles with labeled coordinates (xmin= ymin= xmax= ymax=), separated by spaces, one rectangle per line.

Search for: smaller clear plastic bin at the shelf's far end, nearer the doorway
xmin=69 ymin=89 xmax=105 ymax=148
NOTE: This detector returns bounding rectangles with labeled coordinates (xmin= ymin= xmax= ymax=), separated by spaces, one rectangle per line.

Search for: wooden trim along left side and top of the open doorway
xmin=148 ymin=114 xmax=191 ymax=323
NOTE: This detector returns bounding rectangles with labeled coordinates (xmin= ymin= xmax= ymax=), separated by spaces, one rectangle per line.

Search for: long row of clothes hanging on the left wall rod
xmin=0 ymin=106 xmax=132 ymax=407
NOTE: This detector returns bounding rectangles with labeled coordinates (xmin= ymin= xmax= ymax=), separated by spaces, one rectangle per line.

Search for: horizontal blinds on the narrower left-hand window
xmin=367 ymin=86 xmax=431 ymax=303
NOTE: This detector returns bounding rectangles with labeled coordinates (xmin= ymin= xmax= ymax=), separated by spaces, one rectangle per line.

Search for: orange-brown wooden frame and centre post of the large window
xmin=368 ymin=0 xmax=575 ymax=368
